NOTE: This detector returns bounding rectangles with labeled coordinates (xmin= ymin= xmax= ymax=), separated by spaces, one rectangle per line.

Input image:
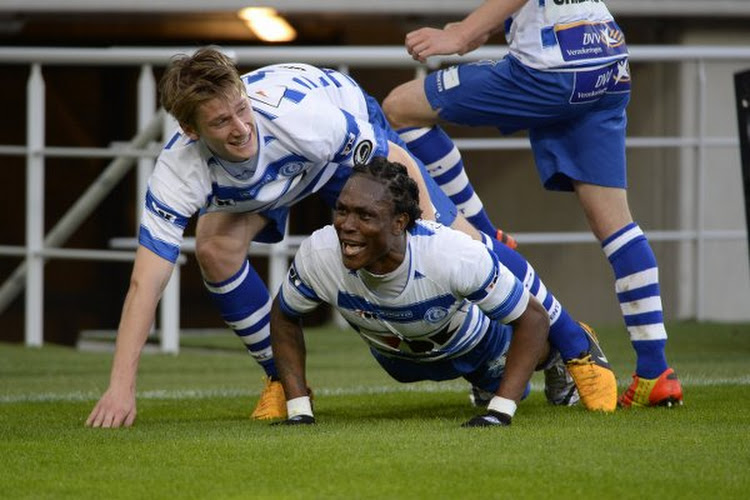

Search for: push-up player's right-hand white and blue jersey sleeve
xmin=452 ymin=229 xmax=529 ymax=323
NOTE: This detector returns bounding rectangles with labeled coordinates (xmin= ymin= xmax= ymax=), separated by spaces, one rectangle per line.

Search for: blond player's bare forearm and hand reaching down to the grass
xmin=86 ymin=246 xmax=173 ymax=427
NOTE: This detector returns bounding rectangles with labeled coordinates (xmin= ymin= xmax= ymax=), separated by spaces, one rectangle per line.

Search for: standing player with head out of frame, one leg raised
xmin=383 ymin=0 xmax=683 ymax=407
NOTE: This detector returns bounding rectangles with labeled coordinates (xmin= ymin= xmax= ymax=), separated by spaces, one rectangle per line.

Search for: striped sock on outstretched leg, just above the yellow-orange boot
xmin=482 ymin=234 xmax=589 ymax=361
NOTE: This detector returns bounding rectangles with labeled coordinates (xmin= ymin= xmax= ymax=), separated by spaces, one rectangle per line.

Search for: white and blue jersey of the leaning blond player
xmin=139 ymin=64 xmax=388 ymax=262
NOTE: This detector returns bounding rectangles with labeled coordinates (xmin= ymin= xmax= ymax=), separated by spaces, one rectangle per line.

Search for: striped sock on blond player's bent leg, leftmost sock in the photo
xmin=203 ymin=260 xmax=277 ymax=378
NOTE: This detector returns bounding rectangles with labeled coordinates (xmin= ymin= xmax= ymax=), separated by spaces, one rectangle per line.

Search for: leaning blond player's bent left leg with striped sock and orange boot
xmin=196 ymin=212 xmax=286 ymax=418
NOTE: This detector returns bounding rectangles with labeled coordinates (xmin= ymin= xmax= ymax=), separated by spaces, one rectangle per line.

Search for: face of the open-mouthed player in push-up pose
xmin=333 ymin=175 xmax=407 ymax=274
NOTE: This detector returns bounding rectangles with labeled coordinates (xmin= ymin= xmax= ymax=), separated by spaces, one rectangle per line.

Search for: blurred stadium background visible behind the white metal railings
xmin=0 ymin=0 xmax=750 ymax=344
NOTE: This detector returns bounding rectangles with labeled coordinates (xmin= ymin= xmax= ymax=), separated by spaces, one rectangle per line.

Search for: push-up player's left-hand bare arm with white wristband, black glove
xmin=271 ymin=294 xmax=315 ymax=425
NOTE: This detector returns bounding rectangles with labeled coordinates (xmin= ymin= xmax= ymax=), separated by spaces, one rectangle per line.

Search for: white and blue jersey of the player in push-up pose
xmin=278 ymin=221 xmax=529 ymax=361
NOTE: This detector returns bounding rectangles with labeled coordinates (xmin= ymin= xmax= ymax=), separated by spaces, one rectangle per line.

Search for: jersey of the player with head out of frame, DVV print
xmin=505 ymin=0 xmax=628 ymax=70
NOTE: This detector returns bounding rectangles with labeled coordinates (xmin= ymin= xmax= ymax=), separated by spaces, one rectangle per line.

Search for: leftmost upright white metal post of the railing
xmin=25 ymin=63 xmax=45 ymax=347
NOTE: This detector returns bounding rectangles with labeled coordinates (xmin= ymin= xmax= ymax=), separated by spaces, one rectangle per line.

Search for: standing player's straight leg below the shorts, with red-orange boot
xmin=575 ymin=183 xmax=682 ymax=406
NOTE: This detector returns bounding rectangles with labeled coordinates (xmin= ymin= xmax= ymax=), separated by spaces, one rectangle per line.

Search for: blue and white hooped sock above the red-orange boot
xmin=602 ymin=222 xmax=667 ymax=378
